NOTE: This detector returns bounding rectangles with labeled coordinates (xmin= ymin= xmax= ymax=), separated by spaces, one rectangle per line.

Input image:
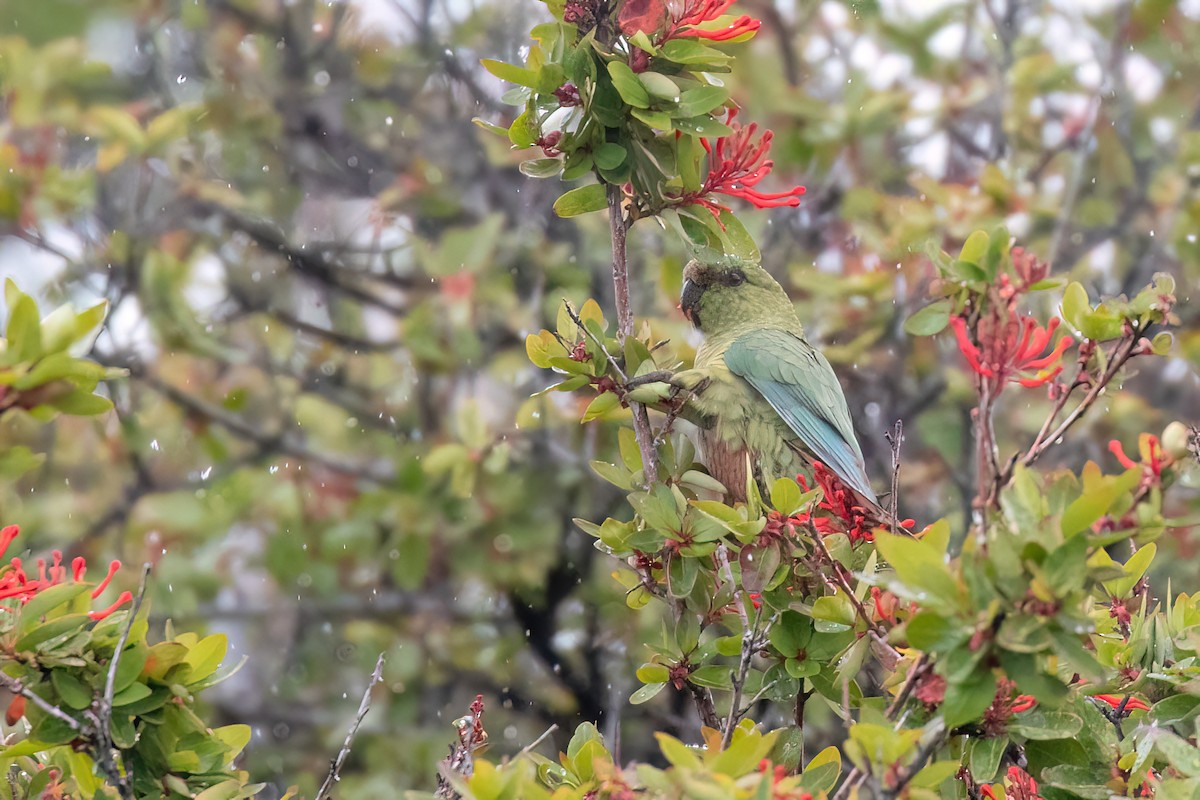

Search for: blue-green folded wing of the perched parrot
xmin=725 ymin=329 xmax=877 ymax=503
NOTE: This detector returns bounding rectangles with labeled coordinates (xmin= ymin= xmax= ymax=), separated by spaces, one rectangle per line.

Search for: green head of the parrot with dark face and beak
xmin=679 ymin=256 xmax=799 ymax=335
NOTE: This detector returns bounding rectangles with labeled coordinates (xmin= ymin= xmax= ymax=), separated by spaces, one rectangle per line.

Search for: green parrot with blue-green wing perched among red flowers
xmin=672 ymin=261 xmax=880 ymax=512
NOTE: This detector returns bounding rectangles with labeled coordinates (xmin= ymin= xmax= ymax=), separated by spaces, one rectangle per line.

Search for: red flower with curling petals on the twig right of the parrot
xmin=950 ymin=306 xmax=1074 ymax=390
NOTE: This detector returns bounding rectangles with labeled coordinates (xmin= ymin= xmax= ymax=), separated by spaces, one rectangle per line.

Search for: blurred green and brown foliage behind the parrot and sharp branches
xmin=0 ymin=0 xmax=1200 ymax=796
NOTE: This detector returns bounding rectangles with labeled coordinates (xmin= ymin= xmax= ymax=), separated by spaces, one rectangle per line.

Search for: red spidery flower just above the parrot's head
xmin=679 ymin=108 xmax=804 ymax=218
